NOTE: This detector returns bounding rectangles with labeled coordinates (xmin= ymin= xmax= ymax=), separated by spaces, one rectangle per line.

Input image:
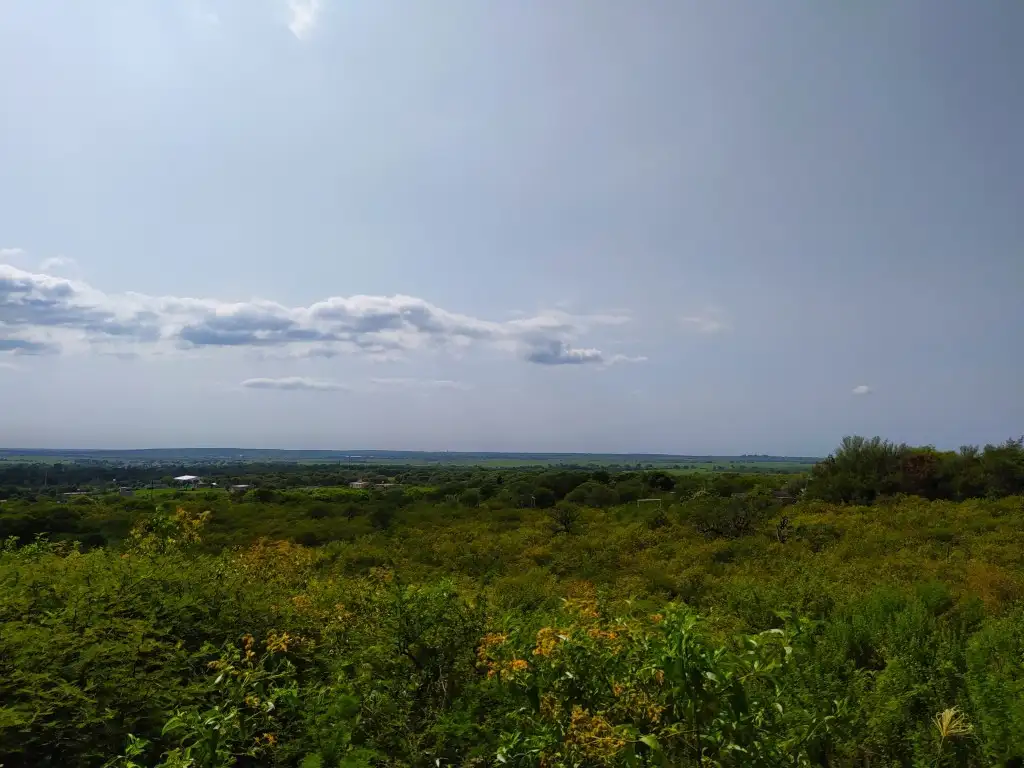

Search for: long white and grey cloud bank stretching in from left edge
xmin=0 ymin=264 xmax=635 ymax=366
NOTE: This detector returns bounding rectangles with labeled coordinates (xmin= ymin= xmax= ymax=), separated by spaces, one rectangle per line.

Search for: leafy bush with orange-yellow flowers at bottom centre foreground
xmin=485 ymin=605 xmax=844 ymax=768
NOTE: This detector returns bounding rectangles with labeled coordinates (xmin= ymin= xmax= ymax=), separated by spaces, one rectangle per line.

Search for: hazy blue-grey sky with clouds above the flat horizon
xmin=0 ymin=0 xmax=1024 ymax=456
